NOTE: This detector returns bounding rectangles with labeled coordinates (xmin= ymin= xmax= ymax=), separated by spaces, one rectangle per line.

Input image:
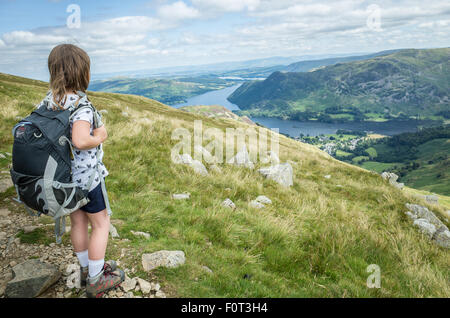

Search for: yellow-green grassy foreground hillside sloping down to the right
xmin=0 ymin=74 xmax=450 ymax=297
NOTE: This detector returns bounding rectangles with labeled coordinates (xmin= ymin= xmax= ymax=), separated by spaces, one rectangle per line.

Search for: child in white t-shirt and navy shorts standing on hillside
xmin=44 ymin=44 xmax=125 ymax=297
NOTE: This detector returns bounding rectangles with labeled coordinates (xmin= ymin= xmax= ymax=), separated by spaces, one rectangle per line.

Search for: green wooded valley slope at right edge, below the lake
xmin=333 ymin=125 xmax=450 ymax=195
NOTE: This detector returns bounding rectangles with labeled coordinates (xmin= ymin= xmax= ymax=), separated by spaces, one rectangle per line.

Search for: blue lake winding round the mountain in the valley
xmin=173 ymin=84 xmax=436 ymax=137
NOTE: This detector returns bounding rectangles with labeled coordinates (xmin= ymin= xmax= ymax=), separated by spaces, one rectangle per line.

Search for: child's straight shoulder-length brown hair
xmin=48 ymin=44 xmax=91 ymax=108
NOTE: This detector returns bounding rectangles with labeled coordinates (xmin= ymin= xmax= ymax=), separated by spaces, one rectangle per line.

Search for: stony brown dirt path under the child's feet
xmin=0 ymin=174 xmax=166 ymax=298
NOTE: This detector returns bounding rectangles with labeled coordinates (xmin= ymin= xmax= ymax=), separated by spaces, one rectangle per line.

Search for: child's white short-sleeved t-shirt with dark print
xmin=39 ymin=94 xmax=108 ymax=191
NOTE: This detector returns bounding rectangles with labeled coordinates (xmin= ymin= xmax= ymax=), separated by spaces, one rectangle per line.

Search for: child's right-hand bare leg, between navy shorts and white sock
xmin=86 ymin=209 xmax=109 ymax=260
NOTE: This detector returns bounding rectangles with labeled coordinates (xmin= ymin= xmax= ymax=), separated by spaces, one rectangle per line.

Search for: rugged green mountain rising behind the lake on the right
xmin=229 ymin=48 xmax=450 ymax=121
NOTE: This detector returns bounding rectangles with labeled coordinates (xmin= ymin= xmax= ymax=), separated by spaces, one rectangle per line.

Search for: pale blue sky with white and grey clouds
xmin=0 ymin=0 xmax=450 ymax=80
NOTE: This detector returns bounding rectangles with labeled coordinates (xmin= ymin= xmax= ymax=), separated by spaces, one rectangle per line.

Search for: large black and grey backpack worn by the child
xmin=10 ymin=92 xmax=111 ymax=243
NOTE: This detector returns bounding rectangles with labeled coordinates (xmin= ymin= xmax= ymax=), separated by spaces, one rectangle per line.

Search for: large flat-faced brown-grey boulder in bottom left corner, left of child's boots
xmin=5 ymin=259 xmax=61 ymax=298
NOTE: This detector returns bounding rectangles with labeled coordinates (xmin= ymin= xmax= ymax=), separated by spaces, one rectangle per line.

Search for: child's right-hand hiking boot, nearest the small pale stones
xmin=86 ymin=263 xmax=125 ymax=298
